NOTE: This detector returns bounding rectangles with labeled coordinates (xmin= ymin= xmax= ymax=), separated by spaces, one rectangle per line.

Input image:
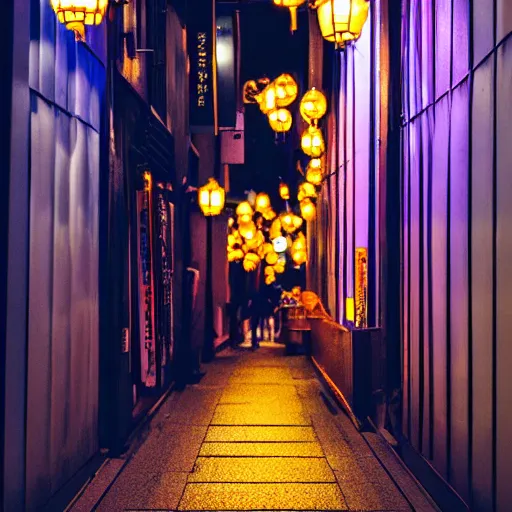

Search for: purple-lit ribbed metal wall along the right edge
xmin=401 ymin=0 xmax=512 ymax=511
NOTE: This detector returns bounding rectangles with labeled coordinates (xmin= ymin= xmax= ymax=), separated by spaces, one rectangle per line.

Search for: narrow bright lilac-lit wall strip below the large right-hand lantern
xmin=337 ymin=2 xmax=380 ymax=326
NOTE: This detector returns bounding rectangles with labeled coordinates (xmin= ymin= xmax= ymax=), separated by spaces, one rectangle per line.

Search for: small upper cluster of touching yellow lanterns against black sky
xmin=244 ymin=73 xmax=299 ymax=133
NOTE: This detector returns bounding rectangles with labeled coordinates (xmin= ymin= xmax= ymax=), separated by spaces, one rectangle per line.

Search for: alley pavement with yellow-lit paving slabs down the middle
xmin=72 ymin=344 xmax=433 ymax=512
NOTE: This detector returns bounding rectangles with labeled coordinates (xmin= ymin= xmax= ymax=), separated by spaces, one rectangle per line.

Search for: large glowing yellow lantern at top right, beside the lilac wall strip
xmin=315 ymin=0 xmax=370 ymax=45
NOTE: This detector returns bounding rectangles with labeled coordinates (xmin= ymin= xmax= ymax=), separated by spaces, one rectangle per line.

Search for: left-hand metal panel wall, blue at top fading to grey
xmin=26 ymin=0 xmax=105 ymax=510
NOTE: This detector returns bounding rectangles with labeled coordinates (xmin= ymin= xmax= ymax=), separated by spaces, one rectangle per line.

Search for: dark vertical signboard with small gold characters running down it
xmin=187 ymin=0 xmax=217 ymax=133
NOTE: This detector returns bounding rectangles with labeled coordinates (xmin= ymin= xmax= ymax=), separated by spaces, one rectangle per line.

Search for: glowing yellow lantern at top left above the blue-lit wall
xmin=51 ymin=0 xmax=109 ymax=39
